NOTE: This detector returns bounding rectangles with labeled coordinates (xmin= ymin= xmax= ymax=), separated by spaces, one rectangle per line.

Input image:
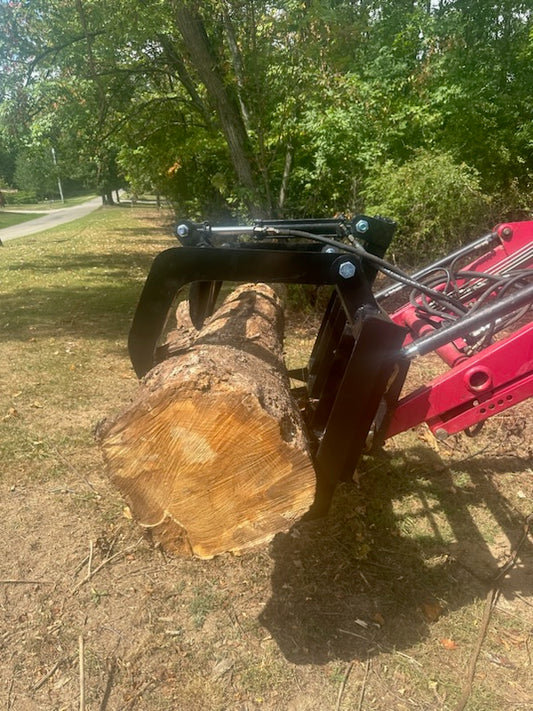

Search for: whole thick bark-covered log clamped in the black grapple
xmin=99 ymin=284 xmax=315 ymax=558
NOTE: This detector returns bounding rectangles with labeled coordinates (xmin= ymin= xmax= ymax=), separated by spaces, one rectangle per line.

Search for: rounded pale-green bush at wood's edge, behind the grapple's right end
xmin=365 ymin=150 xmax=491 ymax=264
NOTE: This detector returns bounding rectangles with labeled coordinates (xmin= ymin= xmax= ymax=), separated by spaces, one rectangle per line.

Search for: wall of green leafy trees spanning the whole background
xmin=0 ymin=0 xmax=533 ymax=246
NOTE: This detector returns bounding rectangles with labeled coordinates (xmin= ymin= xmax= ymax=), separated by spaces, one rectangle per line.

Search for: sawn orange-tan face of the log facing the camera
xmin=104 ymin=393 xmax=314 ymax=558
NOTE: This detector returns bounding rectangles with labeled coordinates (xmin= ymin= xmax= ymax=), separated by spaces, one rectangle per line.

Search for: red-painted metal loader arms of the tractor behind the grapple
xmin=387 ymin=221 xmax=533 ymax=437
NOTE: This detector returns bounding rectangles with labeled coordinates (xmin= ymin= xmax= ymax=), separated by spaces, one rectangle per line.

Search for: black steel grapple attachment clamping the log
xmin=129 ymin=215 xmax=406 ymax=516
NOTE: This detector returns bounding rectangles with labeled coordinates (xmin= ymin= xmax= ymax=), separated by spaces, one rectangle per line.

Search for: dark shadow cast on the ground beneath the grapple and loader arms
xmin=259 ymin=447 xmax=533 ymax=664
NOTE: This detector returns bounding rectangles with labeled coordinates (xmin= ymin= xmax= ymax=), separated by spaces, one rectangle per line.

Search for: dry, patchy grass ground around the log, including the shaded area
xmin=0 ymin=207 xmax=533 ymax=711
